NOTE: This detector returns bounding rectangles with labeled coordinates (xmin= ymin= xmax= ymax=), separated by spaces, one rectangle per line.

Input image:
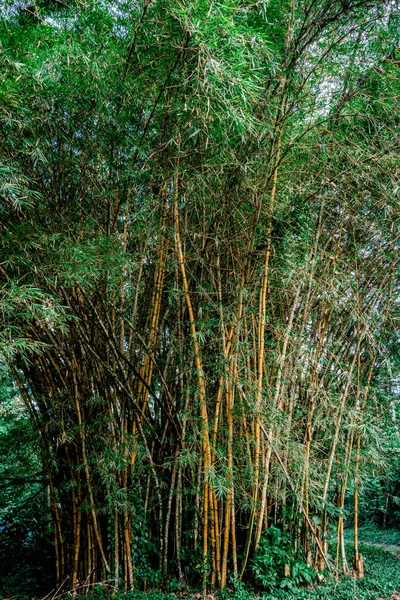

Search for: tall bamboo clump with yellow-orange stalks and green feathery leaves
xmin=0 ymin=0 xmax=400 ymax=590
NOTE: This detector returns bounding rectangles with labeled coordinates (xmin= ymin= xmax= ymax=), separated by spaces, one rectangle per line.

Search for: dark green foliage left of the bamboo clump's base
xmin=0 ymin=371 xmax=54 ymax=597
